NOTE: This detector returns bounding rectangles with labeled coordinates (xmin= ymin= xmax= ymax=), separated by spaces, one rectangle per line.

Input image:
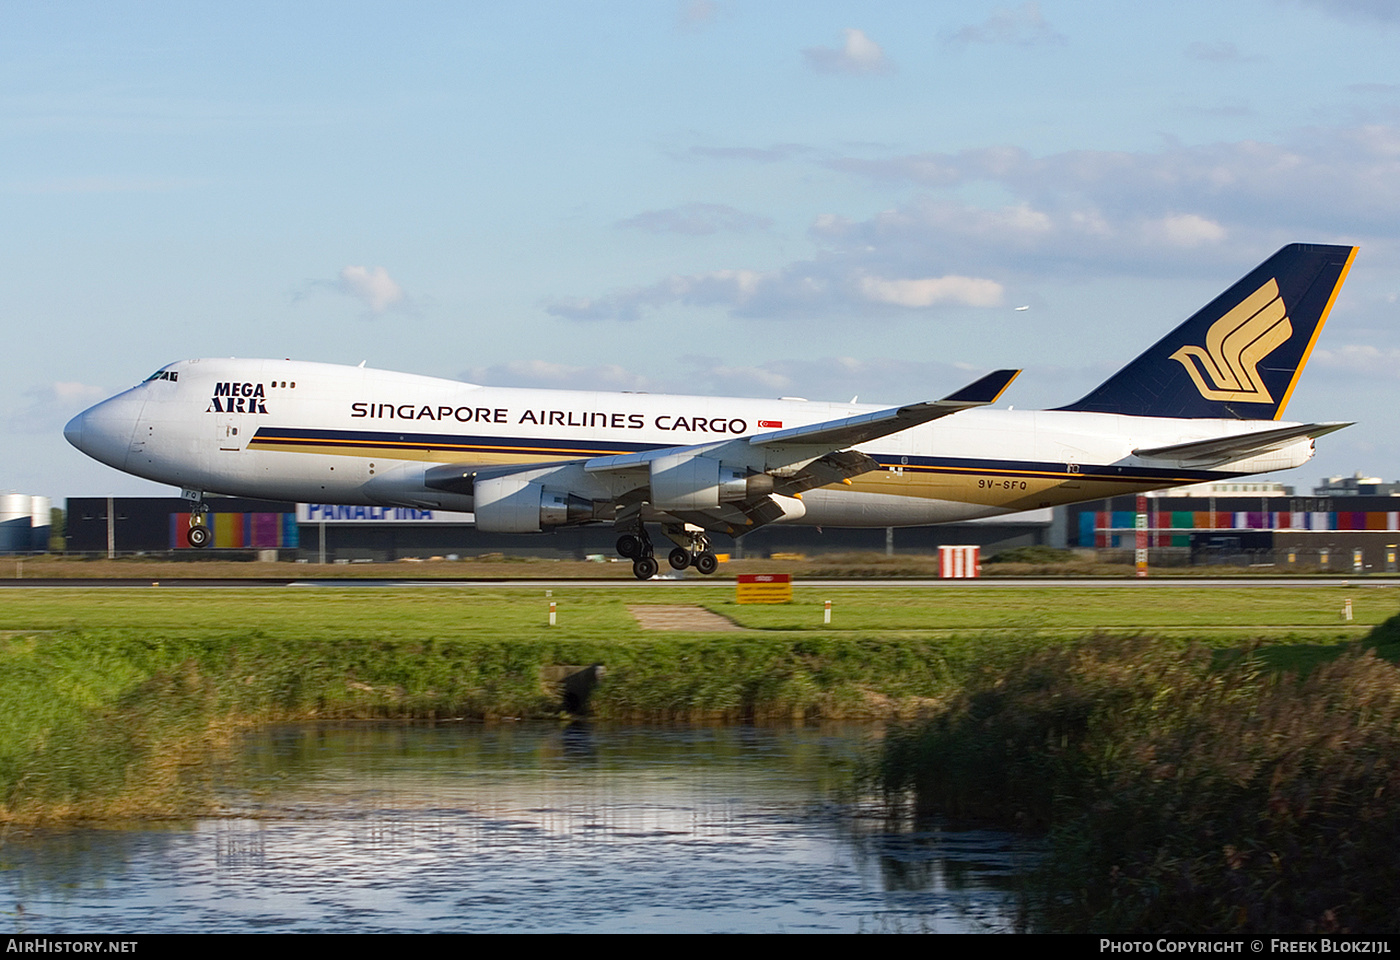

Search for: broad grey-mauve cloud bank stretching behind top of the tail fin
xmin=557 ymin=125 xmax=1400 ymax=323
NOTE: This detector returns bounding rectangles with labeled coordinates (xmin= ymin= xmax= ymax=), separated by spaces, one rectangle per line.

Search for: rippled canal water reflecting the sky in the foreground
xmin=0 ymin=723 xmax=1036 ymax=933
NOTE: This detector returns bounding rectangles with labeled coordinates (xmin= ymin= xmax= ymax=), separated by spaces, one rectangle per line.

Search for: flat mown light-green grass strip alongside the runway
xmin=0 ymin=586 xmax=1400 ymax=641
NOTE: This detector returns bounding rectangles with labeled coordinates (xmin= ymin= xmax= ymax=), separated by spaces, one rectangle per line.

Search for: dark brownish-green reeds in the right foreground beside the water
xmin=876 ymin=616 xmax=1400 ymax=936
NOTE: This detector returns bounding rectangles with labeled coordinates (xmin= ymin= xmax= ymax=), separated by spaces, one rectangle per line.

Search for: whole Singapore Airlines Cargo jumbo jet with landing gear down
xmin=63 ymin=243 xmax=1357 ymax=579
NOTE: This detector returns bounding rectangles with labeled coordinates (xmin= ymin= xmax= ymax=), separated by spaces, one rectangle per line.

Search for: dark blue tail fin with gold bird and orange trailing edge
xmin=1060 ymin=243 xmax=1357 ymax=420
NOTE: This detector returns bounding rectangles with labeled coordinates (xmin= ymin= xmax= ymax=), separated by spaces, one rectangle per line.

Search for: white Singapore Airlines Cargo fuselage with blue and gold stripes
xmin=64 ymin=360 xmax=1312 ymax=526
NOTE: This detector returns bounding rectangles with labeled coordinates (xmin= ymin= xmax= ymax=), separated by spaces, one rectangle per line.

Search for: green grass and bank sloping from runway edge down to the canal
xmin=0 ymin=586 xmax=1394 ymax=821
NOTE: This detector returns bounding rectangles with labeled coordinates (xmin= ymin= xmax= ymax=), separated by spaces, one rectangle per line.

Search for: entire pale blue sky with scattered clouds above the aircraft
xmin=0 ymin=0 xmax=1400 ymax=498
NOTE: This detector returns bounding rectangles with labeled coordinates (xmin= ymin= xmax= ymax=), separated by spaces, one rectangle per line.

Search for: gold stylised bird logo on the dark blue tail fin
xmin=1172 ymin=280 xmax=1294 ymax=403
